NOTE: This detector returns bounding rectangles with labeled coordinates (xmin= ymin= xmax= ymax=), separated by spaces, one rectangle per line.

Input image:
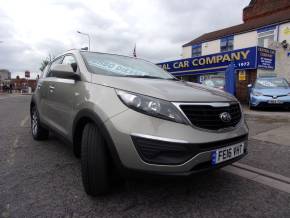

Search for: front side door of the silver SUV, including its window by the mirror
xmin=49 ymin=54 xmax=79 ymax=136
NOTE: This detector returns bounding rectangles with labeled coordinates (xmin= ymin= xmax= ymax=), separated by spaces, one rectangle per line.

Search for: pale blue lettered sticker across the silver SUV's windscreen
xmin=88 ymin=60 xmax=148 ymax=76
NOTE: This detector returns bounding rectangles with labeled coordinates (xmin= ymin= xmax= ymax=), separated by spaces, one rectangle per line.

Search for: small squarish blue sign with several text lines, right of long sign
xmin=257 ymin=47 xmax=275 ymax=70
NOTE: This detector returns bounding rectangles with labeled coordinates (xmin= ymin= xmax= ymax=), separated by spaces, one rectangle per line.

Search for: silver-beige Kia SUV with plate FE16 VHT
xmin=30 ymin=50 xmax=248 ymax=196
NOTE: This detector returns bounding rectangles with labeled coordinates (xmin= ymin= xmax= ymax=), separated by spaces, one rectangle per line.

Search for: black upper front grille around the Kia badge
xmin=180 ymin=103 xmax=242 ymax=130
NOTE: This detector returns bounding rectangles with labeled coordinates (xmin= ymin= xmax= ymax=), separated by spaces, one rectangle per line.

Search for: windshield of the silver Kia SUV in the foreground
xmin=81 ymin=52 xmax=175 ymax=80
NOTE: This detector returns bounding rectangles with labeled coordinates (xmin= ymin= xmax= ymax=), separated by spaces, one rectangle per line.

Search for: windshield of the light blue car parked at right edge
xmin=255 ymin=78 xmax=289 ymax=89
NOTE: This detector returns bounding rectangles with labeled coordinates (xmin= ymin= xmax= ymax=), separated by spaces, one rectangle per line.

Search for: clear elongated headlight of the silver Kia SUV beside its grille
xmin=116 ymin=90 xmax=187 ymax=124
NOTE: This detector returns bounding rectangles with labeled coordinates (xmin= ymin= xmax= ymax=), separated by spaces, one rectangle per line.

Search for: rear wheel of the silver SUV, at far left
xmin=31 ymin=106 xmax=49 ymax=140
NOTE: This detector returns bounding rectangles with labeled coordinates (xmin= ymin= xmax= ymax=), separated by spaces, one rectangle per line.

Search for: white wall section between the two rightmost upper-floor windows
xmin=234 ymin=31 xmax=258 ymax=50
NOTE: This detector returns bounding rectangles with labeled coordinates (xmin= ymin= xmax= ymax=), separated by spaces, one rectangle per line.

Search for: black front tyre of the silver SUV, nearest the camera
xmin=81 ymin=123 xmax=110 ymax=196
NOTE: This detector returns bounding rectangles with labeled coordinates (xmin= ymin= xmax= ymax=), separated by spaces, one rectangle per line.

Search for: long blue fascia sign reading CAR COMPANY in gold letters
xmin=157 ymin=47 xmax=257 ymax=76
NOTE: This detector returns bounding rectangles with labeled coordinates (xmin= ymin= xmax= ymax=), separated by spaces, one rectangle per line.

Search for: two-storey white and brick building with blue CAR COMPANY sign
xmin=158 ymin=0 xmax=290 ymax=102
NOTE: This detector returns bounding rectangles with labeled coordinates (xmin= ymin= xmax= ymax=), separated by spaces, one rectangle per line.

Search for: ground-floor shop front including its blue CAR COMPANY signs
xmin=157 ymin=47 xmax=275 ymax=101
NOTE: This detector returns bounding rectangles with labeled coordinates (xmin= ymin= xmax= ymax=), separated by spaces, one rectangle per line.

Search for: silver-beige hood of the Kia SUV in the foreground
xmin=92 ymin=74 xmax=236 ymax=102
